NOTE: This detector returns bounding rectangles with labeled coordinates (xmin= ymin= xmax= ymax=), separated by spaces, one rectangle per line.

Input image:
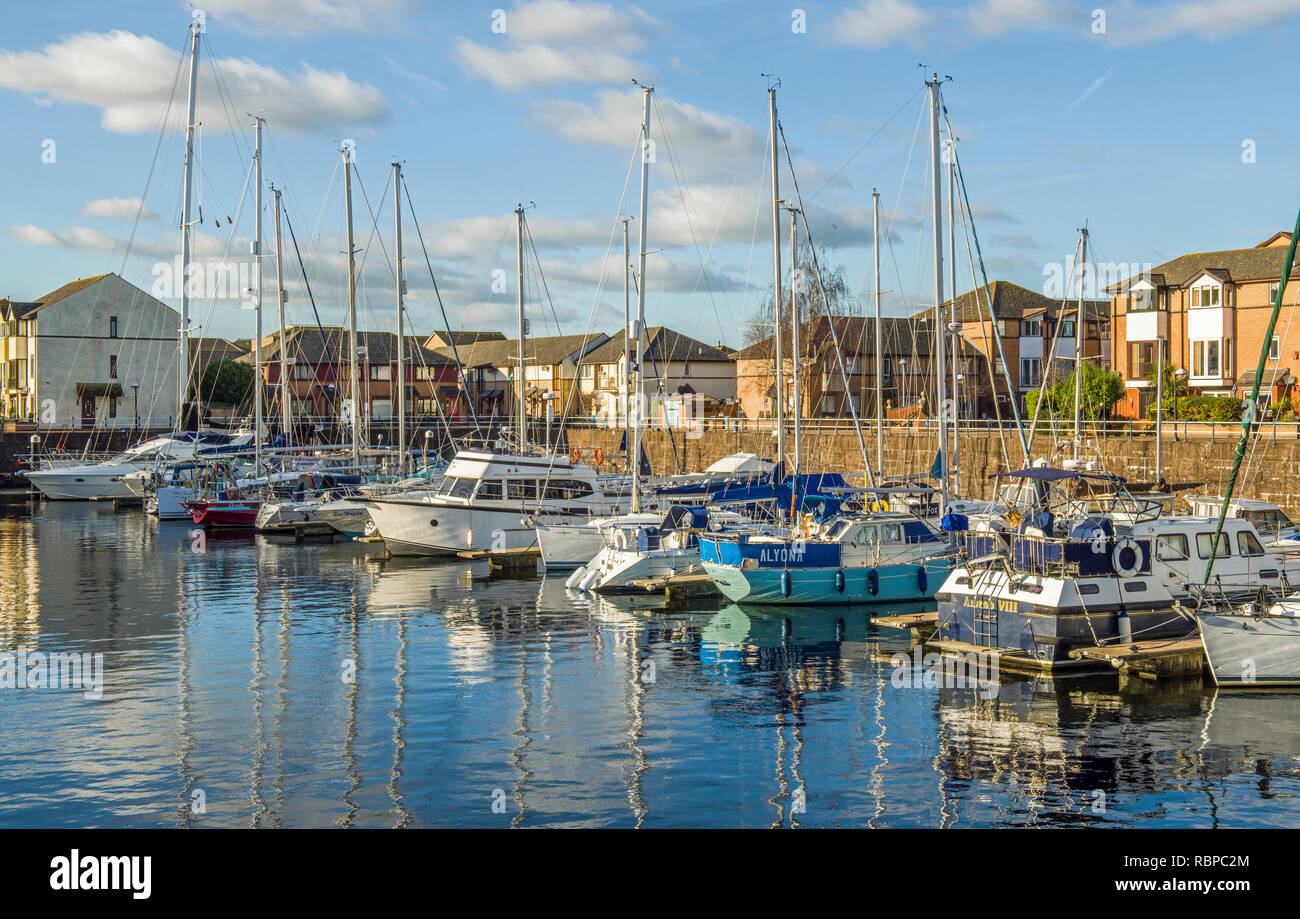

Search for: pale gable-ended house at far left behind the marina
xmin=0 ymin=273 xmax=181 ymax=428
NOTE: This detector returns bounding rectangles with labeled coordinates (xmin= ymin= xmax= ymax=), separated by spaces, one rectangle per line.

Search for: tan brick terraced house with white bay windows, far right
xmin=1108 ymin=233 xmax=1300 ymax=417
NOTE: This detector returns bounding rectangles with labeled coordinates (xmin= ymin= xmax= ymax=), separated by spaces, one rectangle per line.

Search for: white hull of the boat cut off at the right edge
xmin=1197 ymin=615 xmax=1300 ymax=686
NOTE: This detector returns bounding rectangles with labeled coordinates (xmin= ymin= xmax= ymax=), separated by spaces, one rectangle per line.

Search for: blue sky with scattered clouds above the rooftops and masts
xmin=0 ymin=0 xmax=1300 ymax=344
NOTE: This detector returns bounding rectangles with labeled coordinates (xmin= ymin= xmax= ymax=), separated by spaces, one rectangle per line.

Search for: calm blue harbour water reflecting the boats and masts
xmin=0 ymin=494 xmax=1300 ymax=827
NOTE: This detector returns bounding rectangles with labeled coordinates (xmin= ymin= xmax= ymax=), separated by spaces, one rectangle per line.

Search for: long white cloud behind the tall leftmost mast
xmin=0 ymin=30 xmax=389 ymax=134
